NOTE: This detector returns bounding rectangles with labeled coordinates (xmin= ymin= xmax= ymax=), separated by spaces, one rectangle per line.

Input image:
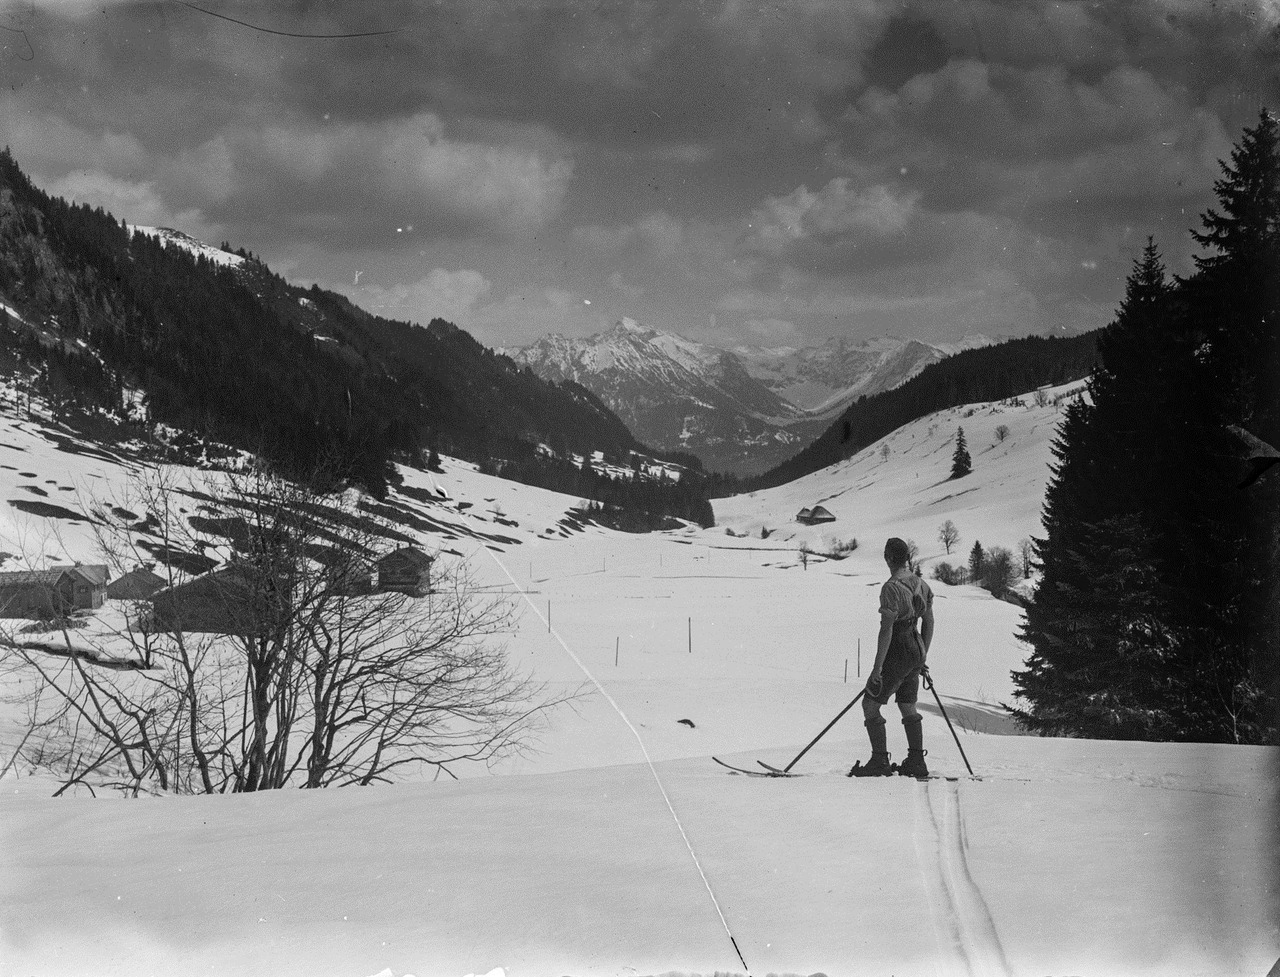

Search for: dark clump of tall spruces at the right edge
xmin=1014 ymin=113 xmax=1280 ymax=743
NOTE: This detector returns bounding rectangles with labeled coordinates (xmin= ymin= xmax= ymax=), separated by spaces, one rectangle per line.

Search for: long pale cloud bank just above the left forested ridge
xmin=0 ymin=99 xmax=573 ymax=246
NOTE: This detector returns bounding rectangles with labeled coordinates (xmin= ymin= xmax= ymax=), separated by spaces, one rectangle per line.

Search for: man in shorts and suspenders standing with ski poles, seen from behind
xmin=849 ymin=537 xmax=933 ymax=777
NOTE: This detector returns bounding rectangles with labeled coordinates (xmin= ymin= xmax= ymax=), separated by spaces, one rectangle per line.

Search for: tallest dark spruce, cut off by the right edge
xmin=1180 ymin=110 xmax=1280 ymax=741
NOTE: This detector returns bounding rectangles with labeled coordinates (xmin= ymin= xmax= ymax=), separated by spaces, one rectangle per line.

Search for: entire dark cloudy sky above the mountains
xmin=0 ymin=0 xmax=1280 ymax=346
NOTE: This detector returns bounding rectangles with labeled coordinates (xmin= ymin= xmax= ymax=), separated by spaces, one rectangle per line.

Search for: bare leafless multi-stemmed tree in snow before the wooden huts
xmin=4 ymin=469 xmax=581 ymax=794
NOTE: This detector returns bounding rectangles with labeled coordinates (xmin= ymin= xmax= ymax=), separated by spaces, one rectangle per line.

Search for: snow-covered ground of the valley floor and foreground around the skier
xmin=0 ymin=391 xmax=1280 ymax=977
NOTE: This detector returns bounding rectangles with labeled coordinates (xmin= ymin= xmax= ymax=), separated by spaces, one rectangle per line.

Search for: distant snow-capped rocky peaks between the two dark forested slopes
xmin=502 ymin=319 xmax=996 ymax=475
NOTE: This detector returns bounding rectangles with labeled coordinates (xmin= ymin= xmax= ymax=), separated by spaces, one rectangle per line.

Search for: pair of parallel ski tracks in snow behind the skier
xmin=914 ymin=781 xmax=1012 ymax=977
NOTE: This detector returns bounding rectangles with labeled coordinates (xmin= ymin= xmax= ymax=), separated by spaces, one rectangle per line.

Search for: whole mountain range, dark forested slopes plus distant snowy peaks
xmin=0 ymin=151 xmax=1096 ymax=504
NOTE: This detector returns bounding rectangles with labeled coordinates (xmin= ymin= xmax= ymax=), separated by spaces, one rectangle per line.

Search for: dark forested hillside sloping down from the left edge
xmin=0 ymin=152 xmax=641 ymax=493
